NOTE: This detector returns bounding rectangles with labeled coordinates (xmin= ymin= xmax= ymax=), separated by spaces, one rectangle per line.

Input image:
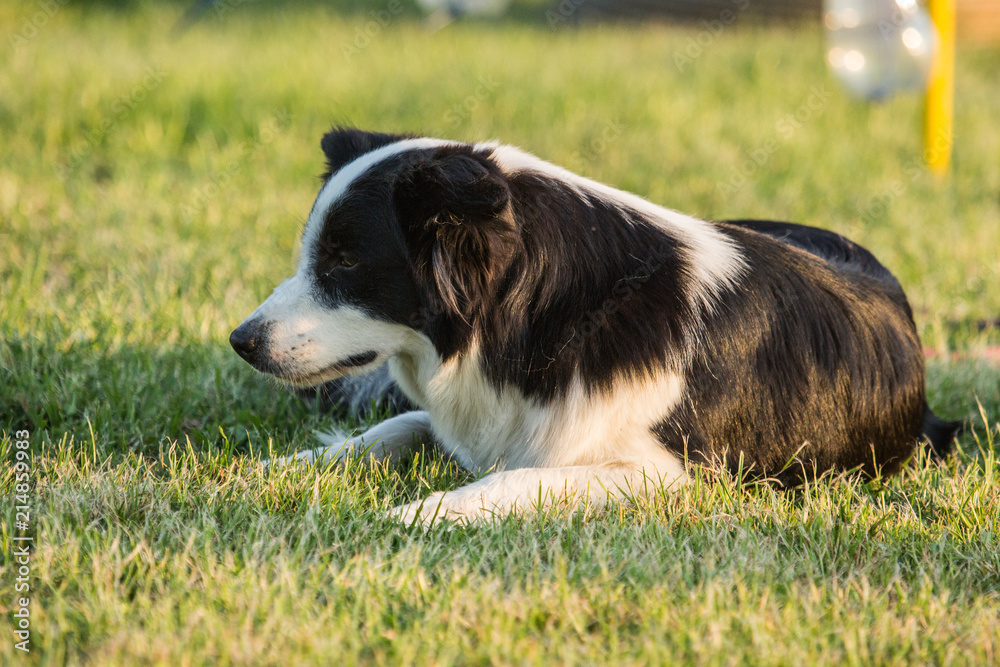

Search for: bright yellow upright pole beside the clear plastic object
xmin=924 ymin=0 xmax=955 ymax=176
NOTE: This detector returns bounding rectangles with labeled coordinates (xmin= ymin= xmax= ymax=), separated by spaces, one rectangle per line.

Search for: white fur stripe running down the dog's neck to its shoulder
xmin=476 ymin=142 xmax=746 ymax=309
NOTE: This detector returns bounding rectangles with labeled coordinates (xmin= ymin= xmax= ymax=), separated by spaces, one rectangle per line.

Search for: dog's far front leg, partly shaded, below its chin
xmin=268 ymin=410 xmax=432 ymax=466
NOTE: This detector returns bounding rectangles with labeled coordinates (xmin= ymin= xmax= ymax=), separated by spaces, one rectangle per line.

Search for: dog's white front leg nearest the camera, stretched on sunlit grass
xmin=392 ymin=451 xmax=687 ymax=524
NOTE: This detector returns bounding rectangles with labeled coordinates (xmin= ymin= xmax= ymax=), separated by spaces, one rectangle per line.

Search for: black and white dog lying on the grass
xmin=230 ymin=129 xmax=958 ymax=522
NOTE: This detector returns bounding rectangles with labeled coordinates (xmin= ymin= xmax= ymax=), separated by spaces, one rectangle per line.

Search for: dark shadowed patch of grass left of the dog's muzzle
xmin=0 ymin=331 xmax=360 ymax=462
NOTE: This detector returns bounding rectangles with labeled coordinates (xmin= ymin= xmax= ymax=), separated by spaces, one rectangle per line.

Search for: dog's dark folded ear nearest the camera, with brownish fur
xmin=393 ymin=146 xmax=520 ymax=323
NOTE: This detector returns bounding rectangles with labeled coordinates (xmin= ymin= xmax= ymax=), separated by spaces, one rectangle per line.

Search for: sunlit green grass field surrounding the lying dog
xmin=0 ymin=2 xmax=1000 ymax=665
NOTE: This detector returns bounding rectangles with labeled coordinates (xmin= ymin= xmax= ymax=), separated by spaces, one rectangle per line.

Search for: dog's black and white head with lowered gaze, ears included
xmin=229 ymin=129 xmax=519 ymax=386
